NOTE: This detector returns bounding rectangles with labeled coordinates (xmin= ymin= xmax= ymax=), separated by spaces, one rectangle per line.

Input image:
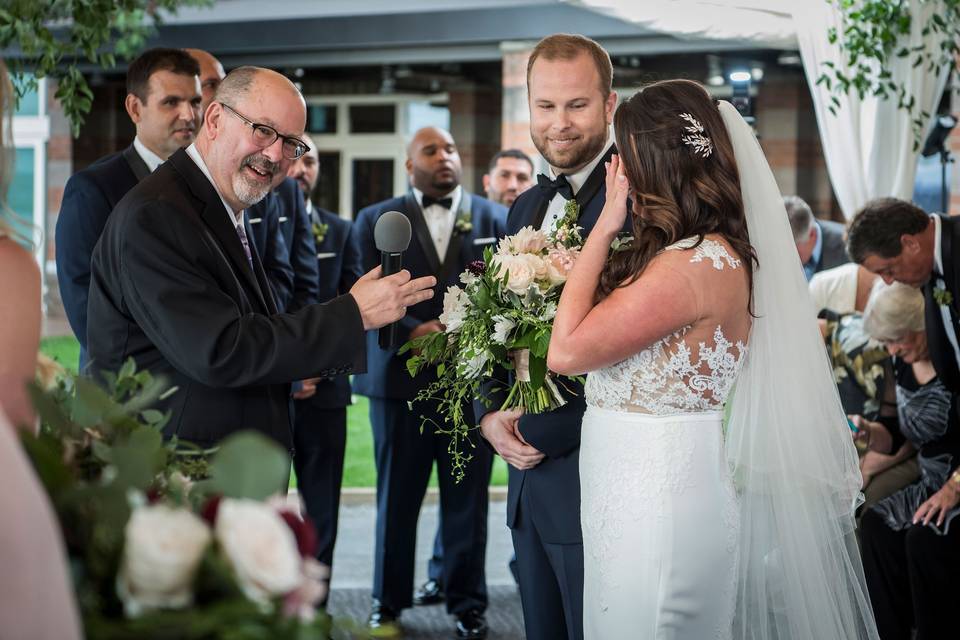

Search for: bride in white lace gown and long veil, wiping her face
xmin=548 ymin=80 xmax=877 ymax=640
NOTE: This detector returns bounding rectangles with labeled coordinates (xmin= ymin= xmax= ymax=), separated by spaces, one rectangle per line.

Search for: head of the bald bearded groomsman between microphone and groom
xmin=406 ymin=127 xmax=463 ymax=198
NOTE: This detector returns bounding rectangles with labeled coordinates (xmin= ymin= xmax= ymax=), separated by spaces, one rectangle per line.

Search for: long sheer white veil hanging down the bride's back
xmin=719 ymin=102 xmax=878 ymax=640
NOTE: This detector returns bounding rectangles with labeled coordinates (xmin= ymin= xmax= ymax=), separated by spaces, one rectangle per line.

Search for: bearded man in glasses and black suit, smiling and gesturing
xmin=88 ymin=67 xmax=435 ymax=450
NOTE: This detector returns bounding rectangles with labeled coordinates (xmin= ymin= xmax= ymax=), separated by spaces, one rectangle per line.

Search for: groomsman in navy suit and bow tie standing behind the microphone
xmin=354 ymin=127 xmax=506 ymax=638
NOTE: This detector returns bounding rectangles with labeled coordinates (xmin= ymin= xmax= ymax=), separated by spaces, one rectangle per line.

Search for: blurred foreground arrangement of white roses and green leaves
xmin=23 ymin=362 xmax=342 ymax=640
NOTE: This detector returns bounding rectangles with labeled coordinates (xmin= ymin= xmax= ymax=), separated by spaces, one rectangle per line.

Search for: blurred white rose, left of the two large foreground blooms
xmin=117 ymin=504 xmax=210 ymax=616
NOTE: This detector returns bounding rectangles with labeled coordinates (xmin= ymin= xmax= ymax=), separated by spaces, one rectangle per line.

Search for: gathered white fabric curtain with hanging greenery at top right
xmin=794 ymin=1 xmax=949 ymax=220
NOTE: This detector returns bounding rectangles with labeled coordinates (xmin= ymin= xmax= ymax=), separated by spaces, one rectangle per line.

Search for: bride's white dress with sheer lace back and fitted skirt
xmin=580 ymin=238 xmax=750 ymax=640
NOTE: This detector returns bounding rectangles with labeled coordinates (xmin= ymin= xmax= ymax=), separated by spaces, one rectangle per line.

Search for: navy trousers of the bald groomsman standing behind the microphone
xmin=370 ymin=398 xmax=493 ymax=614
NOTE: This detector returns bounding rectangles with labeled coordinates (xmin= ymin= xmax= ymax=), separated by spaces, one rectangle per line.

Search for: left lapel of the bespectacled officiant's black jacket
xmin=169 ymin=149 xmax=274 ymax=311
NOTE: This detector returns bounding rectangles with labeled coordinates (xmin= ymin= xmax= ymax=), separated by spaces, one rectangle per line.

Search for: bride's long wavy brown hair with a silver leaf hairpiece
xmin=597 ymin=80 xmax=757 ymax=302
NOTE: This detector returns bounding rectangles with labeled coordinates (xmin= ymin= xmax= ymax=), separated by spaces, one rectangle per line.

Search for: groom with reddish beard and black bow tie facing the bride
xmin=475 ymin=34 xmax=617 ymax=640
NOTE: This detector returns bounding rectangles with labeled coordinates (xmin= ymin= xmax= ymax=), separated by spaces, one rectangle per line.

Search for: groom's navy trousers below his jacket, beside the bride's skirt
xmin=512 ymin=484 xmax=583 ymax=640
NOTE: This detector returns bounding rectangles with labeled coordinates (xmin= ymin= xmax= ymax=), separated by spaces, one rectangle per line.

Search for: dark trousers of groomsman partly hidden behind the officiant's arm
xmin=293 ymin=399 xmax=347 ymax=567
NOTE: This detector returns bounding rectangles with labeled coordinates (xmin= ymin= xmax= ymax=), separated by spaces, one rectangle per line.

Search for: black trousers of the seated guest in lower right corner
xmin=860 ymin=509 xmax=960 ymax=640
